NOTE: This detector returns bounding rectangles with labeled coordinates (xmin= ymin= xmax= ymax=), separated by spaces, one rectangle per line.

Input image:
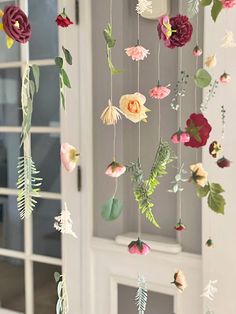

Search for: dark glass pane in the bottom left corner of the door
xmin=0 ymin=257 xmax=25 ymax=314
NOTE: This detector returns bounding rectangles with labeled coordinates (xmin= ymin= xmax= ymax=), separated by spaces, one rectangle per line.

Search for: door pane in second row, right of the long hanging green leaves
xmin=32 ymin=66 xmax=60 ymax=127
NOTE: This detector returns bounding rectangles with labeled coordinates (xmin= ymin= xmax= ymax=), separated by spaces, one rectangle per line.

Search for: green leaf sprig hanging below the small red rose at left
xmin=55 ymin=46 xmax=73 ymax=110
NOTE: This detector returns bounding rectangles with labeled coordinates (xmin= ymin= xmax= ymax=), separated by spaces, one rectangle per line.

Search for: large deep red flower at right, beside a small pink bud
xmin=184 ymin=113 xmax=212 ymax=148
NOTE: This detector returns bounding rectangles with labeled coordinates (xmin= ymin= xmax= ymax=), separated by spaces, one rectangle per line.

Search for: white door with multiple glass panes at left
xmin=0 ymin=0 xmax=79 ymax=314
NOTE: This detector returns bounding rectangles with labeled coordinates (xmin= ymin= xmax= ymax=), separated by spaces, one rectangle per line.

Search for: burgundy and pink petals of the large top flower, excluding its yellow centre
xmin=157 ymin=14 xmax=193 ymax=49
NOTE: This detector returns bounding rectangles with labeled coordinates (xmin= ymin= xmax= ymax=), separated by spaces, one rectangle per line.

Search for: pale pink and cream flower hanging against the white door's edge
xmin=61 ymin=143 xmax=79 ymax=172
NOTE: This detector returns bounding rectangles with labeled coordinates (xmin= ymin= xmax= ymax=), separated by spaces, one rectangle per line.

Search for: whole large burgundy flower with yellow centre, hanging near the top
xmin=157 ymin=14 xmax=193 ymax=49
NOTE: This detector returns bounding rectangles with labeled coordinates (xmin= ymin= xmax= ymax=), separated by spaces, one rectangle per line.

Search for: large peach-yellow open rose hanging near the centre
xmin=120 ymin=93 xmax=150 ymax=123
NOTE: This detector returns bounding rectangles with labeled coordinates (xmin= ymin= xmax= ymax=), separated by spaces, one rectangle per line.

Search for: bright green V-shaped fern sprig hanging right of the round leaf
xmin=127 ymin=140 xmax=176 ymax=228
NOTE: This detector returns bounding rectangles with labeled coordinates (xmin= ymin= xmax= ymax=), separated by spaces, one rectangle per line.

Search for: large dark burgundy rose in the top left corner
xmin=2 ymin=5 xmax=31 ymax=44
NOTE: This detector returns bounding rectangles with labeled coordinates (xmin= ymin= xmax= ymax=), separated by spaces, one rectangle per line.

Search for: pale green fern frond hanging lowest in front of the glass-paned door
xmin=17 ymin=156 xmax=42 ymax=219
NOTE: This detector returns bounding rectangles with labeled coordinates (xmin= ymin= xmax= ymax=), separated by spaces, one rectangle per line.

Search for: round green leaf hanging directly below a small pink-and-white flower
xmin=101 ymin=198 xmax=123 ymax=221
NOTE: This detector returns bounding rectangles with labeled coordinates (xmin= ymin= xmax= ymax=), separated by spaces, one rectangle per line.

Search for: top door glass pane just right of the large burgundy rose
xmin=29 ymin=0 xmax=58 ymax=60
